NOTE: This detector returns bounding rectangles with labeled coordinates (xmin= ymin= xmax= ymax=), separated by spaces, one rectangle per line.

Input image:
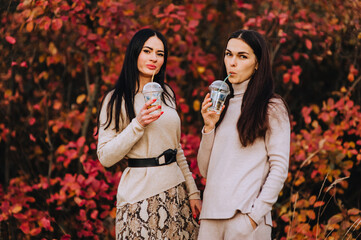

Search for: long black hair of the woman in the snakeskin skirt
xmin=98 ymin=29 xmax=176 ymax=131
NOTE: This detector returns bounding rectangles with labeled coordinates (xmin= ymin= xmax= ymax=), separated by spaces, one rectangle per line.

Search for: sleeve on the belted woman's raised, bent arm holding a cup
xmin=97 ymin=94 xmax=144 ymax=167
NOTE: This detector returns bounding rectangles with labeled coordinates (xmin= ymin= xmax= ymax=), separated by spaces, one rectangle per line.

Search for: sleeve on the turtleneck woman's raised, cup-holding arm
xmin=197 ymin=128 xmax=215 ymax=178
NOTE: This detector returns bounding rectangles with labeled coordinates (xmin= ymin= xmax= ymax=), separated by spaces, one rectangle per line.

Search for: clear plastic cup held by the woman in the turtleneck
xmin=207 ymin=80 xmax=230 ymax=114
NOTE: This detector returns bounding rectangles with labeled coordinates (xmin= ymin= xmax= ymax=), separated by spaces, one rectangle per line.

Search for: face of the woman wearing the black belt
xmin=137 ymin=36 xmax=164 ymax=78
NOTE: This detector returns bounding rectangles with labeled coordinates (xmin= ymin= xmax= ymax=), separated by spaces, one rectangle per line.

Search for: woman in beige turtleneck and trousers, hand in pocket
xmin=198 ymin=30 xmax=290 ymax=240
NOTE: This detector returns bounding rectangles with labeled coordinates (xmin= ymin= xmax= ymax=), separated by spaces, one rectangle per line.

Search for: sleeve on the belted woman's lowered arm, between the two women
xmin=177 ymin=144 xmax=201 ymax=199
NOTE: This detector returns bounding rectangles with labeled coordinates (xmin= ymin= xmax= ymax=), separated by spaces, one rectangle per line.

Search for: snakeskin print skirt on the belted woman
xmin=116 ymin=183 xmax=199 ymax=240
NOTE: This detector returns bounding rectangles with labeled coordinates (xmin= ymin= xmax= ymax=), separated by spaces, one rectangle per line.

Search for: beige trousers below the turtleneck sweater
xmin=198 ymin=212 xmax=272 ymax=240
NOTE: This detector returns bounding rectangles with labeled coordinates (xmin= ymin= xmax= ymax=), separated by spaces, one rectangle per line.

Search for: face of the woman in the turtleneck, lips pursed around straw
xmin=224 ymin=38 xmax=258 ymax=84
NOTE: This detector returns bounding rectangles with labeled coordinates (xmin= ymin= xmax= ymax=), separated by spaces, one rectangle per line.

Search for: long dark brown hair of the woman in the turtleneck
xmin=217 ymin=30 xmax=288 ymax=147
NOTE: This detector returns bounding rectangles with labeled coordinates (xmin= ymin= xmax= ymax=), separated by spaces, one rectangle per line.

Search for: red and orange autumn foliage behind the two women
xmin=0 ymin=0 xmax=361 ymax=240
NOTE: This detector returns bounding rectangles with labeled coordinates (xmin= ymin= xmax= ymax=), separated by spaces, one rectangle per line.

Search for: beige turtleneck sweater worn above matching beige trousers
xmin=198 ymin=80 xmax=290 ymax=225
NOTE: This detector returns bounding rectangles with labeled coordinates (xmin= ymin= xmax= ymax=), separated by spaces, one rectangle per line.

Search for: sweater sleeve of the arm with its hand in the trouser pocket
xmin=249 ymin=102 xmax=291 ymax=224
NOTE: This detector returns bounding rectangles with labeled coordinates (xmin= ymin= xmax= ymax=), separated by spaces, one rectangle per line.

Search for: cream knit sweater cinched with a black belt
xmin=97 ymin=92 xmax=200 ymax=207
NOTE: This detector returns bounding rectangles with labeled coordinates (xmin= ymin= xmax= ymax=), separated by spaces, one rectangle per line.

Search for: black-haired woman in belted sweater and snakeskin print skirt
xmin=98 ymin=29 xmax=201 ymax=240
